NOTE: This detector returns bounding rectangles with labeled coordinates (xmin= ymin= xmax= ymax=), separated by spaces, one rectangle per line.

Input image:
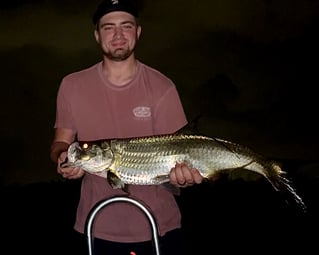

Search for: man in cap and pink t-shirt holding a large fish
xmin=51 ymin=0 xmax=203 ymax=255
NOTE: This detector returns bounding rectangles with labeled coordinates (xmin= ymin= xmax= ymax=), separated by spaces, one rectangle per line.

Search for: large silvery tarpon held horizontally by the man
xmin=61 ymin=134 xmax=303 ymax=209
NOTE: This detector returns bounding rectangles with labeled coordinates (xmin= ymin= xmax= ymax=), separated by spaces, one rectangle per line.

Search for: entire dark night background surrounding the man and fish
xmin=0 ymin=0 xmax=319 ymax=254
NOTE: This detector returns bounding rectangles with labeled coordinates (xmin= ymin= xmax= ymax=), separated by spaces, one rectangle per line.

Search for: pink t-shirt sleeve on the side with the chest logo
xmin=153 ymin=86 xmax=187 ymax=134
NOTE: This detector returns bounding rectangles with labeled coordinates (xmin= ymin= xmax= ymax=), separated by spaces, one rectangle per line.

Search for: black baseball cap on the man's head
xmin=92 ymin=0 xmax=138 ymax=25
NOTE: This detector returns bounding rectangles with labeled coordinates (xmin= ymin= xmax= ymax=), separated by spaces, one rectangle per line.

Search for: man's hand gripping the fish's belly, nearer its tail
xmin=169 ymin=163 xmax=203 ymax=187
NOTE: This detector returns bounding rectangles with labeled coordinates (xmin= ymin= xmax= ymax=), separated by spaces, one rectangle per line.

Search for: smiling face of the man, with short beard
xmin=95 ymin=11 xmax=141 ymax=61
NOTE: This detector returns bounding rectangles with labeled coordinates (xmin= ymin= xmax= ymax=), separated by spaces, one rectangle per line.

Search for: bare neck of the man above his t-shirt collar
xmin=102 ymin=56 xmax=137 ymax=86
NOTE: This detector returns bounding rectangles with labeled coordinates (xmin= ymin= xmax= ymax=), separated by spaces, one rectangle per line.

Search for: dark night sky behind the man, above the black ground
xmin=0 ymin=0 xmax=319 ymax=185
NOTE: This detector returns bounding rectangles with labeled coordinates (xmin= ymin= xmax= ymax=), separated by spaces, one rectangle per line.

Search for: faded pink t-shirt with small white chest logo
xmin=55 ymin=62 xmax=187 ymax=242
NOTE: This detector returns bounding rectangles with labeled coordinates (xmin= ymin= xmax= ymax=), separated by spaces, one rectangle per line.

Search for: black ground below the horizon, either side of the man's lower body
xmin=2 ymin=158 xmax=319 ymax=255
